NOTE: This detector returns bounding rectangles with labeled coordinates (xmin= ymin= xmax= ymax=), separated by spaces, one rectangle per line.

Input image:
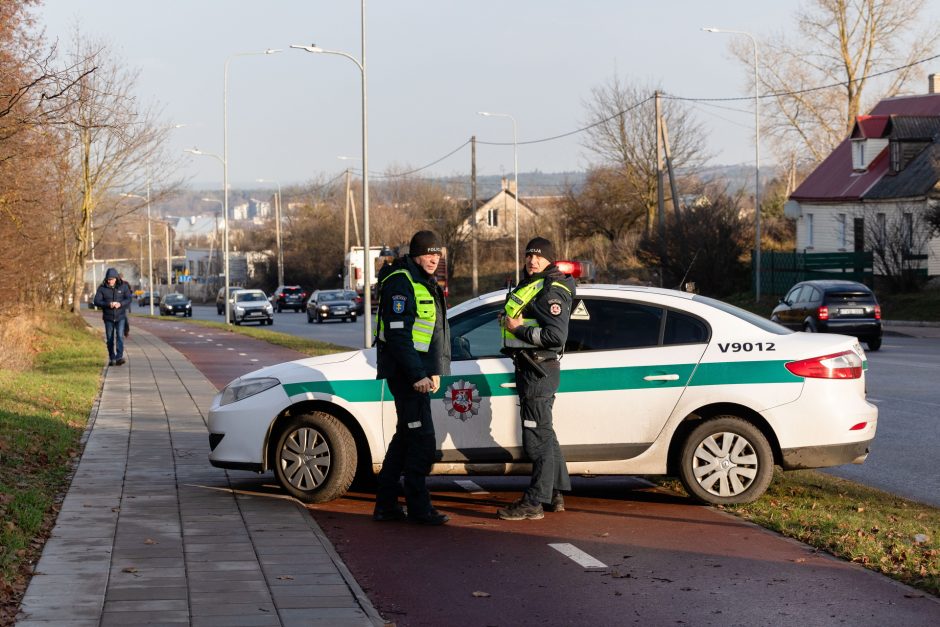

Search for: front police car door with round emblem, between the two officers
xmin=431 ymin=302 xmax=523 ymax=463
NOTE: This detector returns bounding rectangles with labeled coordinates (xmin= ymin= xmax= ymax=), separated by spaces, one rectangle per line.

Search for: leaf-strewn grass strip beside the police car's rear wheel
xmin=662 ymin=470 xmax=940 ymax=596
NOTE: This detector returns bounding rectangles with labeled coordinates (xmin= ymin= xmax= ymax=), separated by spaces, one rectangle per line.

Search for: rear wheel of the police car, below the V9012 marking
xmin=679 ymin=416 xmax=774 ymax=505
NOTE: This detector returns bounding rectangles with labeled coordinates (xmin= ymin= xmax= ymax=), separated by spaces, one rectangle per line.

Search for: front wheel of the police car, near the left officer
xmin=273 ymin=411 xmax=357 ymax=503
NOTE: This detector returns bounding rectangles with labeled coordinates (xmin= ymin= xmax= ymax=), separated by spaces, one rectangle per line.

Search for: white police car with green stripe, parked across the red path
xmin=209 ymin=285 xmax=878 ymax=504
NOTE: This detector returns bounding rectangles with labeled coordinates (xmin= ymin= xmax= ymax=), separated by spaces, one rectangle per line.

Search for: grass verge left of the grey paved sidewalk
xmin=0 ymin=312 xmax=107 ymax=625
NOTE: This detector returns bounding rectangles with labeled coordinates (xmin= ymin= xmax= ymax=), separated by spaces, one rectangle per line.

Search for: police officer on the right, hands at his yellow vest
xmin=497 ymin=237 xmax=575 ymax=520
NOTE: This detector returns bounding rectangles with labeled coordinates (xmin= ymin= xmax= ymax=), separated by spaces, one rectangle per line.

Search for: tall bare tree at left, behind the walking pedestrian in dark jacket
xmin=47 ymin=30 xmax=182 ymax=312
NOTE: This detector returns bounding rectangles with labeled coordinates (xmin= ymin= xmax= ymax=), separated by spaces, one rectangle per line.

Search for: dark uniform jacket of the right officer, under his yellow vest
xmin=513 ymin=264 xmax=575 ymax=359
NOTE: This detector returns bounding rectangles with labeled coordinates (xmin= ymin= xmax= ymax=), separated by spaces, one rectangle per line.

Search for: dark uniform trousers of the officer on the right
xmin=516 ymin=359 xmax=571 ymax=503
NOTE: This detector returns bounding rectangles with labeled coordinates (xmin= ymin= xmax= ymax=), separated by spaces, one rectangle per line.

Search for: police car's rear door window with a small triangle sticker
xmin=565 ymin=298 xmax=663 ymax=352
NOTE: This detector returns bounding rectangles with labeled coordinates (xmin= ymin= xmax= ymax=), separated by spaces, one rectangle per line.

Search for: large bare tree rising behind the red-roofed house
xmin=731 ymin=0 xmax=940 ymax=163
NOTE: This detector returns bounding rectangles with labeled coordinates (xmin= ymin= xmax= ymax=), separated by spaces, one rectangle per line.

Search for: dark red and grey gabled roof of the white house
xmin=790 ymin=94 xmax=940 ymax=202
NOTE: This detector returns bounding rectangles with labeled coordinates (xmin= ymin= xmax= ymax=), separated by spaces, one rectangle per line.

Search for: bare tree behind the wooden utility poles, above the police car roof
xmin=584 ymin=76 xmax=708 ymax=236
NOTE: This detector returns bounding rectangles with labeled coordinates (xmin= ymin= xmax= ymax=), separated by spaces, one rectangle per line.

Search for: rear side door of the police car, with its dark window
xmin=553 ymin=297 xmax=710 ymax=462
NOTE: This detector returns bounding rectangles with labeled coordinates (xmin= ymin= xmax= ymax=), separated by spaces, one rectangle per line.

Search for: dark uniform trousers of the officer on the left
xmin=375 ymin=374 xmax=437 ymax=516
